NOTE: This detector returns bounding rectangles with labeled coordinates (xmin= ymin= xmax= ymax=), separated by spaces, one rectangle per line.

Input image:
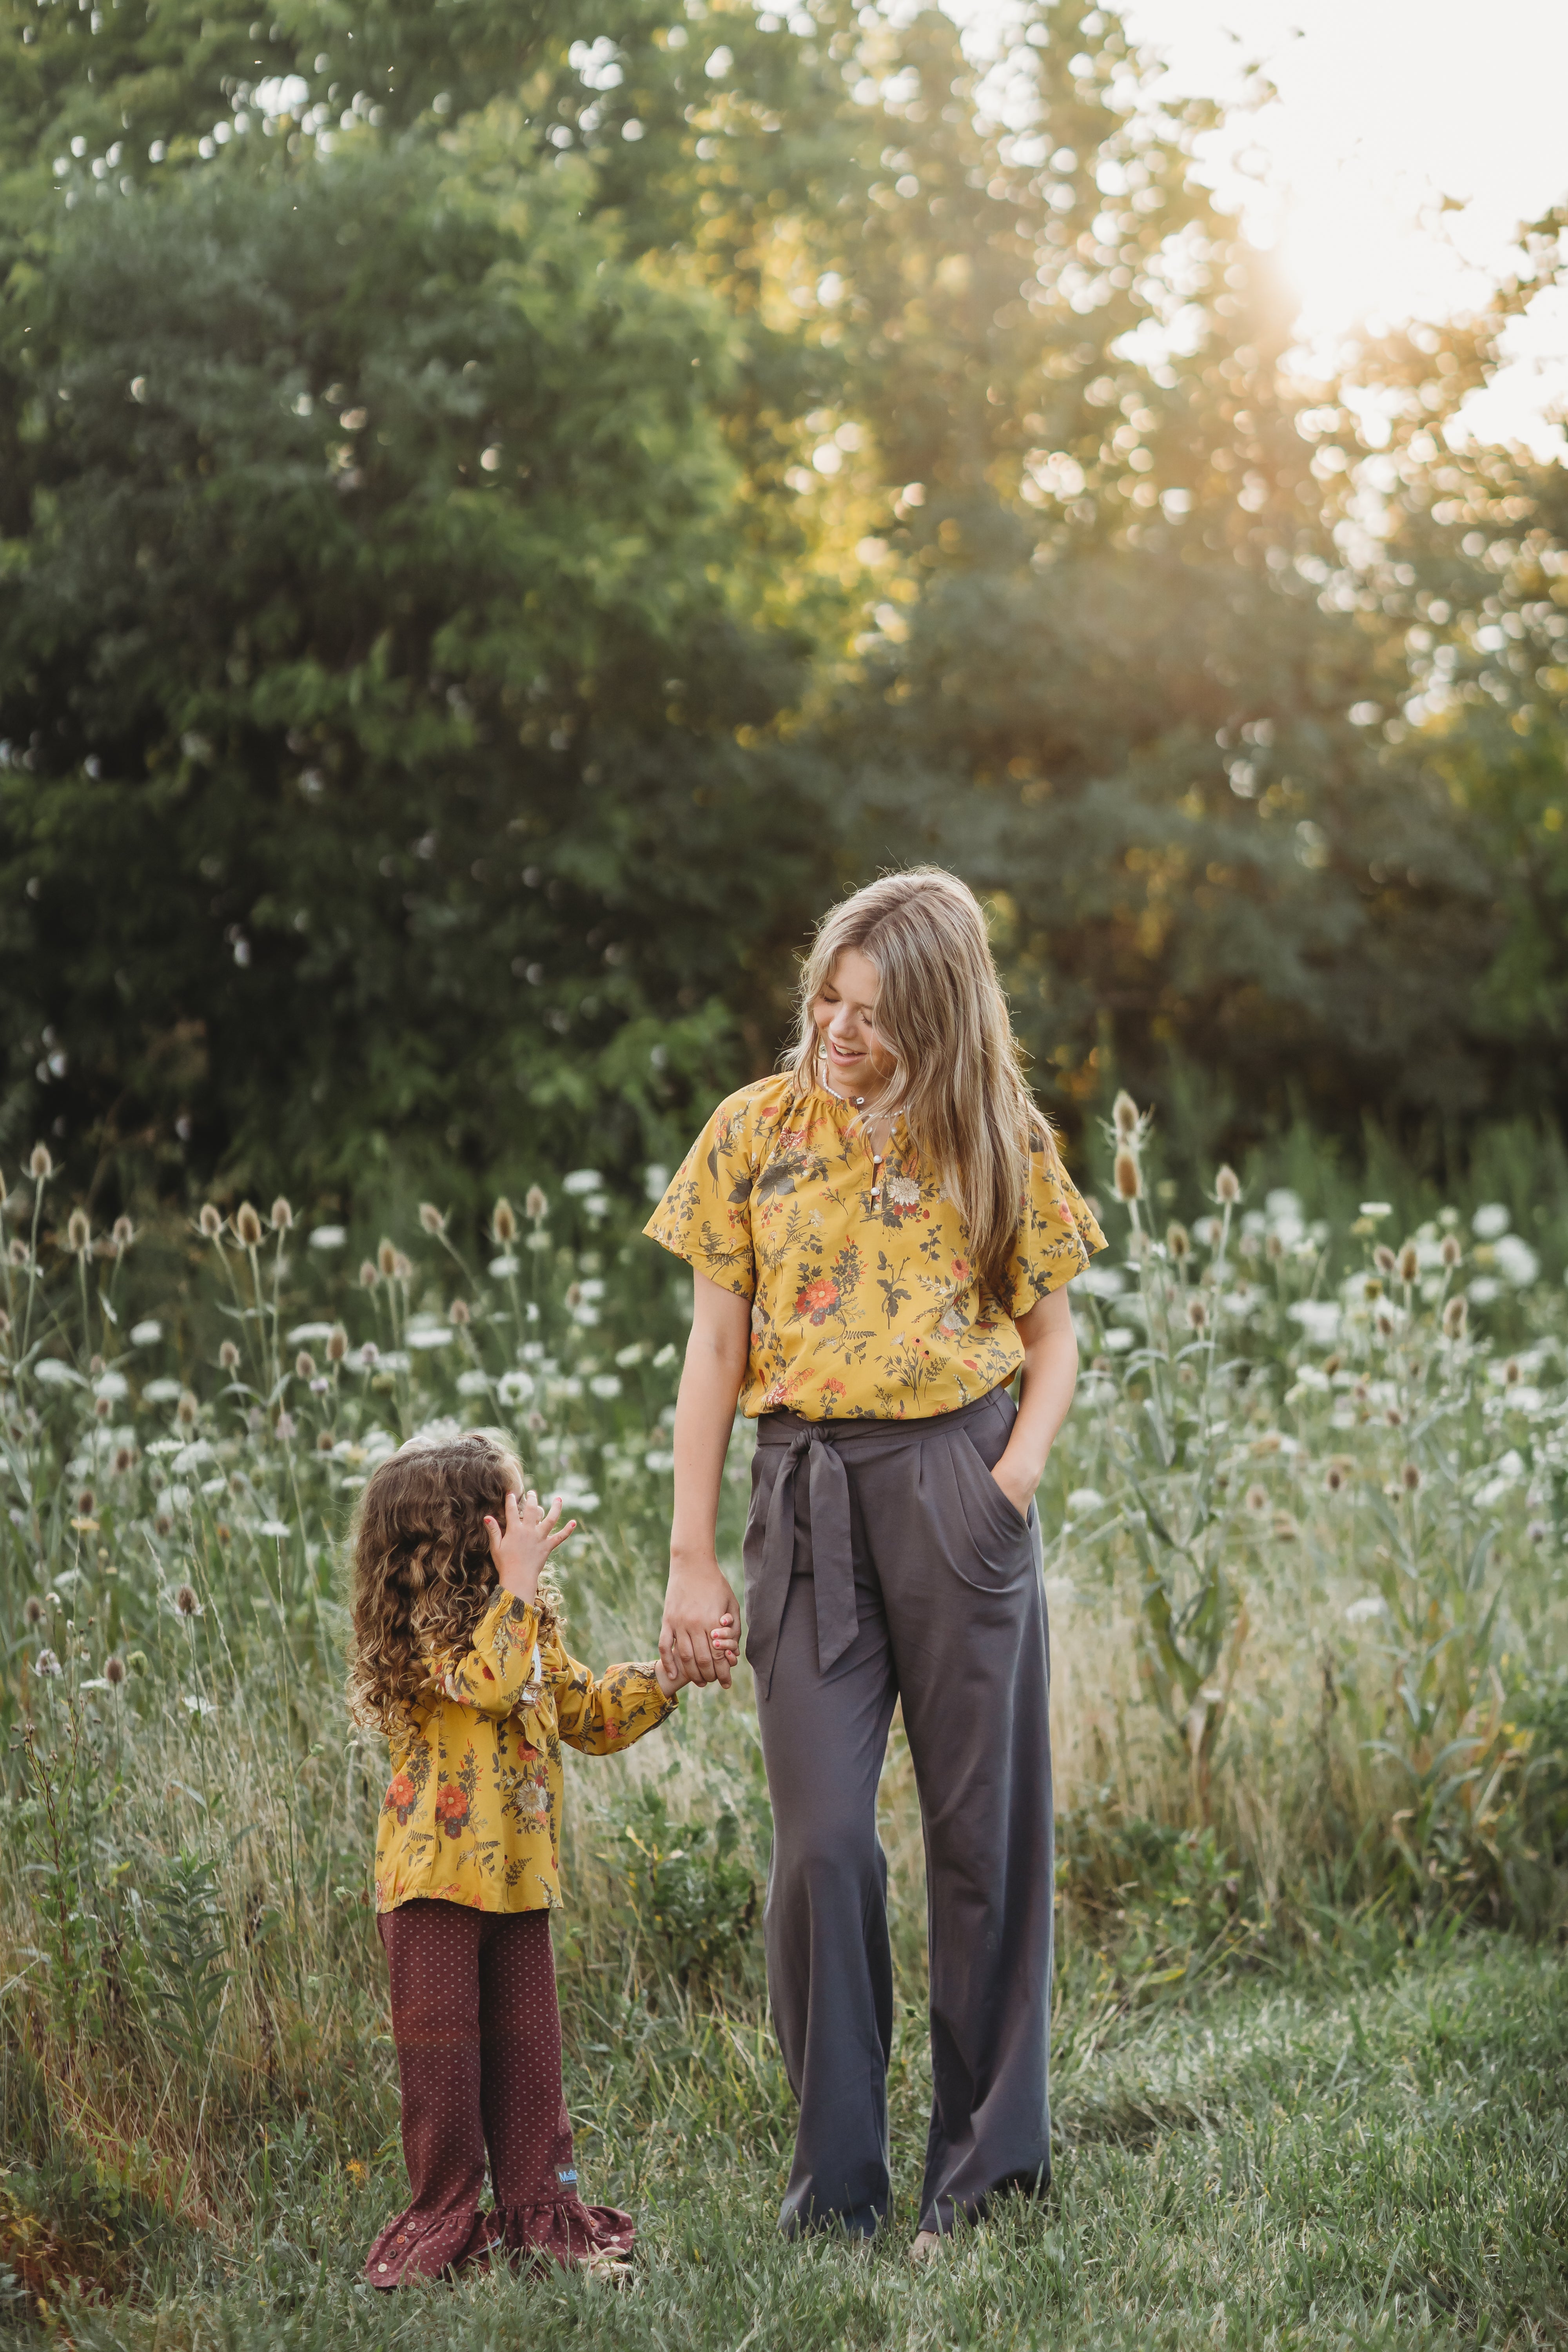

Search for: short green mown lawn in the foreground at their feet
xmin=24 ymin=1938 xmax=1568 ymax=2352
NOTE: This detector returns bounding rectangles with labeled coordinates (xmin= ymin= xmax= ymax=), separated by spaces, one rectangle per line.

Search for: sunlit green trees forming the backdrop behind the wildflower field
xmin=0 ymin=0 xmax=1563 ymax=1185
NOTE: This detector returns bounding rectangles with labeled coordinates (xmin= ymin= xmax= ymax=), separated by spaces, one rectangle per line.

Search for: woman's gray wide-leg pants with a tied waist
xmin=745 ymin=1390 xmax=1053 ymax=2232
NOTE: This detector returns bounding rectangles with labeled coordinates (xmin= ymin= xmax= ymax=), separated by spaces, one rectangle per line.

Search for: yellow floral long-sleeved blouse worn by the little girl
xmin=376 ymin=1592 xmax=677 ymax=1912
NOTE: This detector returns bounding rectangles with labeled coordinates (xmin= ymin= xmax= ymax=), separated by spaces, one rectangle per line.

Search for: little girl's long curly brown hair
xmin=348 ymin=1430 xmax=524 ymax=1736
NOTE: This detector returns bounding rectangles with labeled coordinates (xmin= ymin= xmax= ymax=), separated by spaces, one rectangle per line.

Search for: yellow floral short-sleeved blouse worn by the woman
xmin=644 ymin=1077 xmax=1105 ymax=1421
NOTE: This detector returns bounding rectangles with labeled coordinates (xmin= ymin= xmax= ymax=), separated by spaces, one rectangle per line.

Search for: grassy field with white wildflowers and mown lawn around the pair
xmin=0 ymin=1124 xmax=1568 ymax=2352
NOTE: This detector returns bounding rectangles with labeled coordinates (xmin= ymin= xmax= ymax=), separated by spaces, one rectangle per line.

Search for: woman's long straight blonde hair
xmin=790 ymin=866 xmax=1056 ymax=1305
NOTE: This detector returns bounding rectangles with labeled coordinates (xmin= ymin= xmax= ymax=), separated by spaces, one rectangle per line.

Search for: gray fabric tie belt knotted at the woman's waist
xmin=745 ymin=1390 xmax=997 ymax=1696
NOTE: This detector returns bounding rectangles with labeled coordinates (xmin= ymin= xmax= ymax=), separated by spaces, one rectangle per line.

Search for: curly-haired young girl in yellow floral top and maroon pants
xmin=348 ymin=1435 xmax=733 ymax=2286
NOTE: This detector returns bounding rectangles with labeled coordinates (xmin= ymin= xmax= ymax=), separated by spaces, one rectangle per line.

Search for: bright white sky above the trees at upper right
xmin=1123 ymin=0 xmax=1568 ymax=456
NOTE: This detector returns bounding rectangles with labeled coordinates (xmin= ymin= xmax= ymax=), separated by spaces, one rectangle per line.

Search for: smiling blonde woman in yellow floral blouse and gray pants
xmin=646 ymin=868 xmax=1105 ymax=2256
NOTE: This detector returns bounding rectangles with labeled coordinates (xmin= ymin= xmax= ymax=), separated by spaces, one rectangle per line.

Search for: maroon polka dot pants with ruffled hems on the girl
xmin=365 ymin=1900 xmax=632 ymax=2286
